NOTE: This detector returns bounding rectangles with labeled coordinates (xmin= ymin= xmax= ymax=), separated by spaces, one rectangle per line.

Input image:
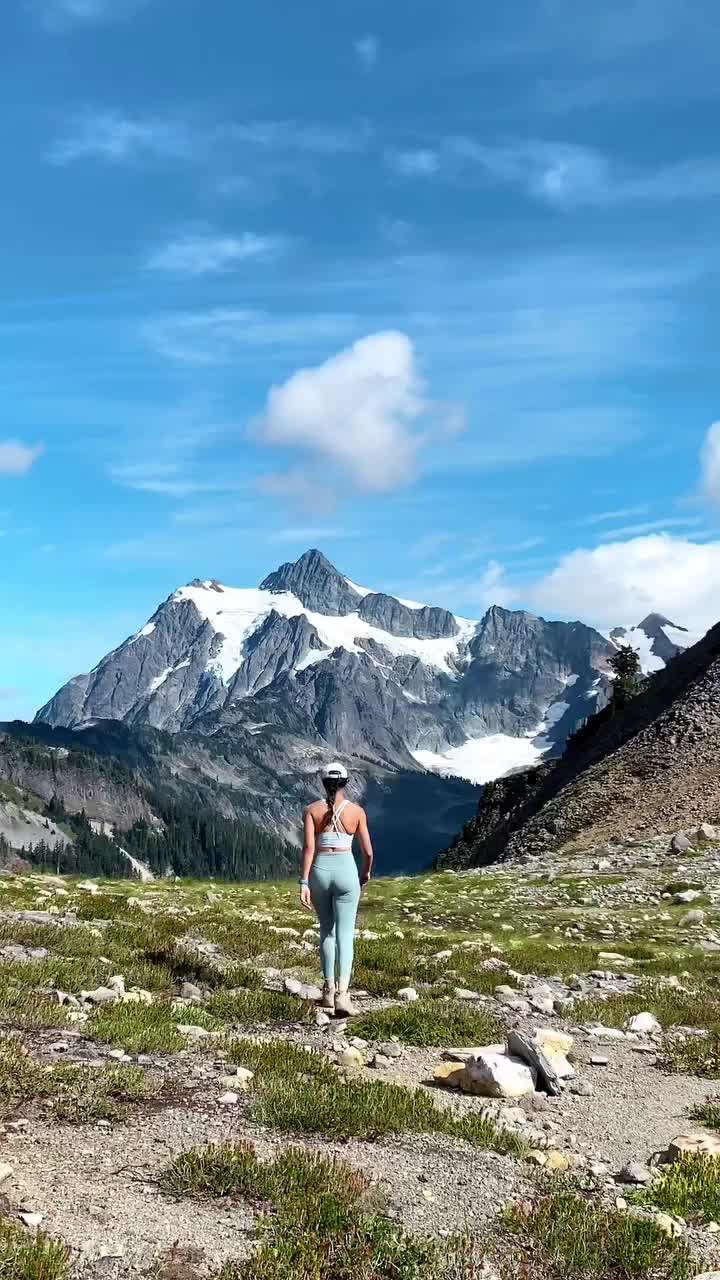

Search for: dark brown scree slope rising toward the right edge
xmin=441 ymin=623 xmax=720 ymax=867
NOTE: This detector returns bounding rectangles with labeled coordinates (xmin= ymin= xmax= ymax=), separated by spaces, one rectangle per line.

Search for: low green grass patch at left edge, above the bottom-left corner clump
xmin=0 ymin=1037 xmax=160 ymax=1124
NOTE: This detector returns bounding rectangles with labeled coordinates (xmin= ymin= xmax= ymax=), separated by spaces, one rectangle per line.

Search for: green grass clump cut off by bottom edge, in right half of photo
xmin=503 ymin=1192 xmax=693 ymax=1280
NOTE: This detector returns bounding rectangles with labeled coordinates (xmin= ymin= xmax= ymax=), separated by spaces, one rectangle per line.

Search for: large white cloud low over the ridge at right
xmin=524 ymin=534 xmax=720 ymax=631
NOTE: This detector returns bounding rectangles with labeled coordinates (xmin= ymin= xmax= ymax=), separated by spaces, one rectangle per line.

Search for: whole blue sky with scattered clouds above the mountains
xmin=0 ymin=0 xmax=720 ymax=718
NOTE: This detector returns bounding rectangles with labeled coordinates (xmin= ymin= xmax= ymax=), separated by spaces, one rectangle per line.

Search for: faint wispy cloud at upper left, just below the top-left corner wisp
xmin=47 ymin=111 xmax=190 ymax=165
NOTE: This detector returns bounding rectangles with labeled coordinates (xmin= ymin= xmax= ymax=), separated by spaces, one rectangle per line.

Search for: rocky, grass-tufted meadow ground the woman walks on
xmin=0 ymin=828 xmax=720 ymax=1280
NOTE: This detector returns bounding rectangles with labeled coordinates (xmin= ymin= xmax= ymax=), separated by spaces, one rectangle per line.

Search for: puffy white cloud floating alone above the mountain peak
xmin=255 ymin=332 xmax=432 ymax=497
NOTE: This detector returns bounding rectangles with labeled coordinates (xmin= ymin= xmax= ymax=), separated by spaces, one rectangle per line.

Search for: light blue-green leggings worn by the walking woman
xmin=310 ymin=854 xmax=360 ymax=988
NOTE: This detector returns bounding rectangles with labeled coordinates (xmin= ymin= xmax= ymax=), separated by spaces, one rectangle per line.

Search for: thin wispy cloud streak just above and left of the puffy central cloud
xmin=142 ymin=307 xmax=356 ymax=365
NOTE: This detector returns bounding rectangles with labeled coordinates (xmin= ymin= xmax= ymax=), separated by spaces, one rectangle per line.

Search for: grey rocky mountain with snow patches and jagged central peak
xmin=37 ymin=550 xmax=611 ymax=782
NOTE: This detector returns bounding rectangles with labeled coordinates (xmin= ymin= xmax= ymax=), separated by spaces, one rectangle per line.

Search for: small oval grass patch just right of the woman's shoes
xmin=352 ymin=1000 xmax=505 ymax=1048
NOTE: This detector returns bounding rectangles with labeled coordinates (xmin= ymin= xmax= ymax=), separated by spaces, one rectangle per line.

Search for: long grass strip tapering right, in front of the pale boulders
xmin=256 ymin=1075 xmax=524 ymax=1155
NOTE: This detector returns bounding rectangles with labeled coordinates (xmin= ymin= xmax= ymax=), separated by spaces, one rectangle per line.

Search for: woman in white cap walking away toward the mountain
xmin=300 ymin=763 xmax=373 ymax=1016
